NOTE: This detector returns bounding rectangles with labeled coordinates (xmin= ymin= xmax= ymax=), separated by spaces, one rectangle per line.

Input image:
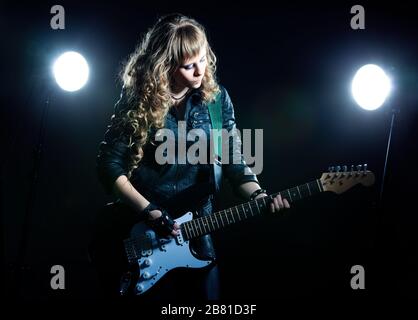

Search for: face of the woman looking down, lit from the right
xmin=173 ymin=48 xmax=207 ymax=90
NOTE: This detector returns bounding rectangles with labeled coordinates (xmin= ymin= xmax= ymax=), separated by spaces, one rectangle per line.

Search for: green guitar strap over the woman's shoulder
xmin=208 ymin=93 xmax=223 ymax=192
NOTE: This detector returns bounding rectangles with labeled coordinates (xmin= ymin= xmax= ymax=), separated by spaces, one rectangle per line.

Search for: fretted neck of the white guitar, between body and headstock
xmin=181 ymin=179 xmax=324 ymax=240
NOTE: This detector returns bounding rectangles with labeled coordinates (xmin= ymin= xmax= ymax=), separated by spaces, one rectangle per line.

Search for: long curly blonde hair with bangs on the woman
xmin=114 ymin=14 xmax=220 ymax=174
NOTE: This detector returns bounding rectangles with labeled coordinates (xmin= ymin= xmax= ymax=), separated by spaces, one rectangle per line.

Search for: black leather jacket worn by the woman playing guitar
xmin=97 ymin=86 xmax=258 ymax=258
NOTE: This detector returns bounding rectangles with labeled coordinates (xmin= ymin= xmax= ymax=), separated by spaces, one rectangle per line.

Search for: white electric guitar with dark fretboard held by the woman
xmin=89 ymin=165 xmax=375 ymax=295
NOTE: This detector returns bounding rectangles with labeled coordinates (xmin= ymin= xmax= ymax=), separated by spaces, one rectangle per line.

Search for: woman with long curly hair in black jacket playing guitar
xmin=98 ymin=14 xmax=289 ymax=299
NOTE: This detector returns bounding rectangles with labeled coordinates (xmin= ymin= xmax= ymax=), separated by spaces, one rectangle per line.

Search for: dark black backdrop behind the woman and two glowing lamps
xmin=0 ymin=1 xmax=418 ymax=301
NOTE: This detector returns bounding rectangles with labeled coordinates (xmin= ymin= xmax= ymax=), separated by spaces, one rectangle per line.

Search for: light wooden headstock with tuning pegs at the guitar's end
xmin=319 ymin=164 xmax=375 ymax=194
